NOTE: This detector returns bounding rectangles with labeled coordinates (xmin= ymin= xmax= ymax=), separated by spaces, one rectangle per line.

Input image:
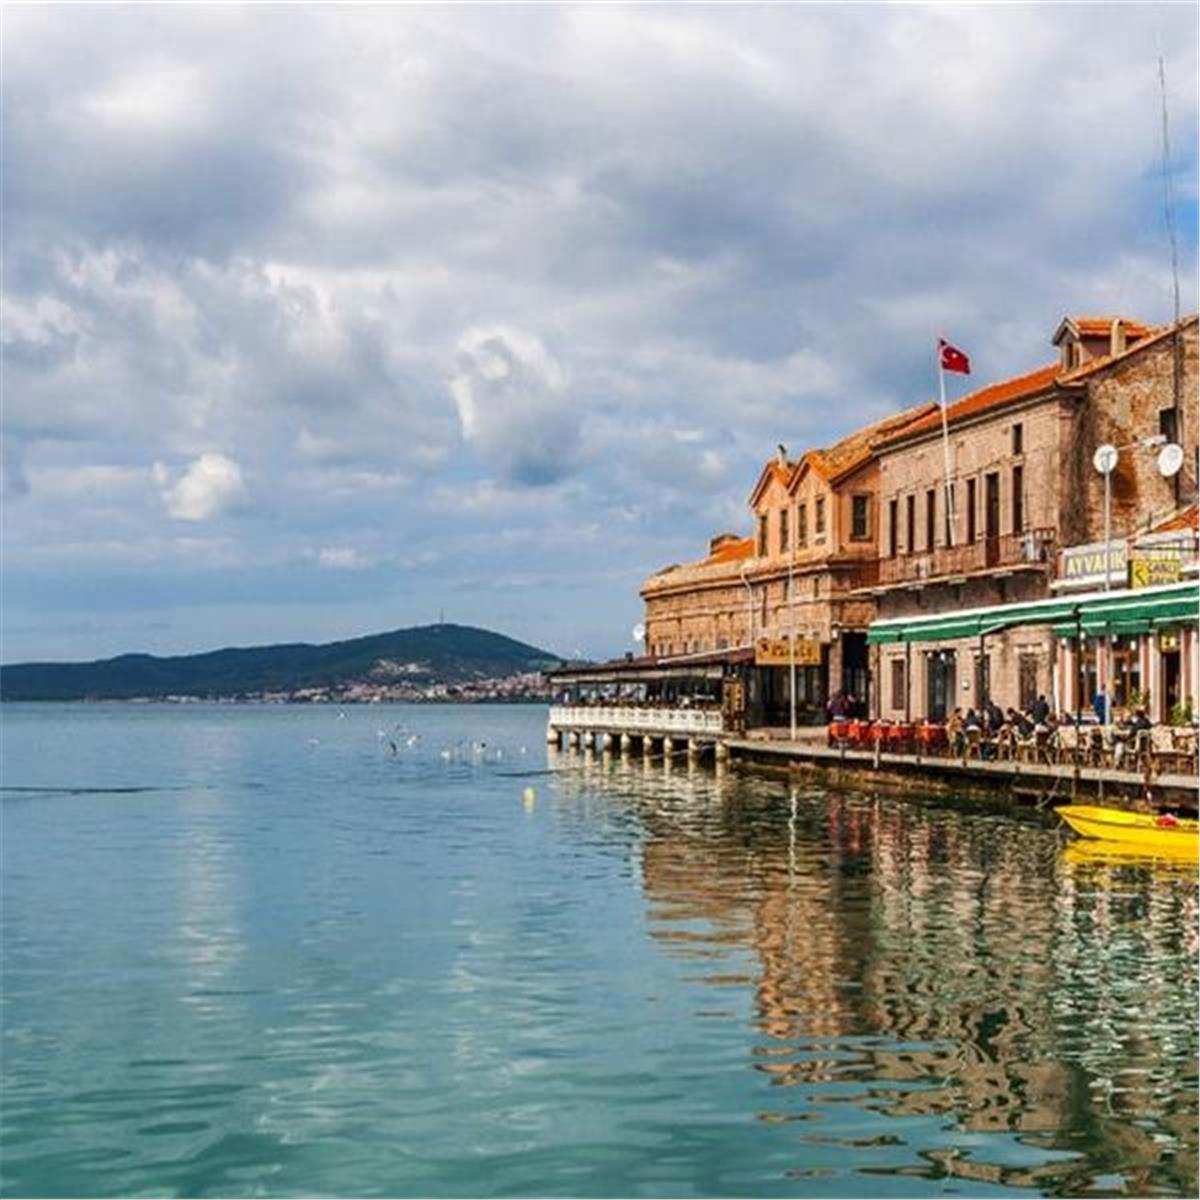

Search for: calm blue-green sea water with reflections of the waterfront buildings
xmin=0 ymin=704 xmax=1198 ymax=1196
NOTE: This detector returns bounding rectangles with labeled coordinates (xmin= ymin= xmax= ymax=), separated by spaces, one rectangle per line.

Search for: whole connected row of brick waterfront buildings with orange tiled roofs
xmin=641 ymin=317 xmax=1200 ymax=724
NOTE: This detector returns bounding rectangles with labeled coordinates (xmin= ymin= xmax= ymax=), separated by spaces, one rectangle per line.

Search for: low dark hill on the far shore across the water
xmin=0 ymin=625 xmax=560 ymax=700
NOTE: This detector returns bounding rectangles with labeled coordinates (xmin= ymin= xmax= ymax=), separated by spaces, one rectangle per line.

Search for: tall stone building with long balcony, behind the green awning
xmin=872 ymin=317 xmax=1198 ymax=720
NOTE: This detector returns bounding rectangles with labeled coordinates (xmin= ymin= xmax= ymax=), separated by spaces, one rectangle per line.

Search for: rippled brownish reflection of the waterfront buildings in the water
xmin=556 ymin=756 xmax=1198 ymax=1196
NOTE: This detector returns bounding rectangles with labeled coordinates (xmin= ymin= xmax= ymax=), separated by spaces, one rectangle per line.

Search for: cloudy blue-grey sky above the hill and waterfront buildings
xmin=0 ymin=4 xmax=1198 ymax=662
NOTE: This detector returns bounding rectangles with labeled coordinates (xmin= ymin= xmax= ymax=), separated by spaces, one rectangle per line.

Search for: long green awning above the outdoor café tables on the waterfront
xmin=866 ymin=581 xmax=1200 ymax=646
